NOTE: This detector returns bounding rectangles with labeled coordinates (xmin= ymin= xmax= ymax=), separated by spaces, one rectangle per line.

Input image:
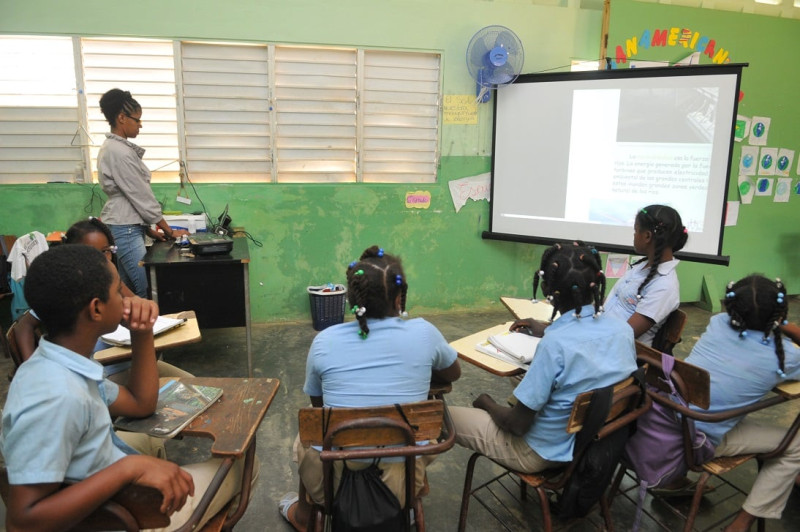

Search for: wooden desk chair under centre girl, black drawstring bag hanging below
xmin=298 ymin=399 xmax=455 ymax=532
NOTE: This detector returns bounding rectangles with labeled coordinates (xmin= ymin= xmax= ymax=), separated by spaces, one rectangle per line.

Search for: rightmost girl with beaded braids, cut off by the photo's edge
xmin=686 ymin=275 xmax=800 ymax=532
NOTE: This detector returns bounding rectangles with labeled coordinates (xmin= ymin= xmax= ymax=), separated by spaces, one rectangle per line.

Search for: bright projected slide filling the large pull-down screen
xmin=489 ymin=67 xmax=740 ymax=262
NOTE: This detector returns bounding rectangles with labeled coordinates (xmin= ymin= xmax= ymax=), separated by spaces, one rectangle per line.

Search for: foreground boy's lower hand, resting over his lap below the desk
xmin=123 ymin=455 xmax=194 ymax=515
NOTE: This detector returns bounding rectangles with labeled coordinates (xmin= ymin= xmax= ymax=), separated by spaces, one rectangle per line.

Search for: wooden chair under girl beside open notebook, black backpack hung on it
xmin=458 ymin=377 xmax=650 ymax=532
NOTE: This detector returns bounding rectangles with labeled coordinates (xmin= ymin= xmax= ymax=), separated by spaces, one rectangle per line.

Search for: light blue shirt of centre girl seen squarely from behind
xmin=303 ymin=318 xmax=458 ymax=408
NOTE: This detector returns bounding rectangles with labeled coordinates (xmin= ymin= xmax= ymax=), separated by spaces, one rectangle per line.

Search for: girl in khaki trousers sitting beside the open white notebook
xmin=450 ymin=245 xmax=636 ymax=473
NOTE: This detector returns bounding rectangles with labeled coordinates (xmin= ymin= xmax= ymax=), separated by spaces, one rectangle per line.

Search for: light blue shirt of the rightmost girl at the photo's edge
xmin=686 ymin=313 xmax=800 ymax=446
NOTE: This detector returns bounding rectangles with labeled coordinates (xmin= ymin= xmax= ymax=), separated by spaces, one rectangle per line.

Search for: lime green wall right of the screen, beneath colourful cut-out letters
xmin=608 ymin=0 xmax=800 ymax=301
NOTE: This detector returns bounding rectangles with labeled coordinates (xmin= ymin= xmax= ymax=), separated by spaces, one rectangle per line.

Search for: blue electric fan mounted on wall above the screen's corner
xmin=467 ymin=26 xmax=525 ymax=103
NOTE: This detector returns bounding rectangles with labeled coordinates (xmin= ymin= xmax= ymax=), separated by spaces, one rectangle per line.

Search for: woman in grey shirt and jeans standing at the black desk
xmin=97 ymin=89 xmax=186 ymax=298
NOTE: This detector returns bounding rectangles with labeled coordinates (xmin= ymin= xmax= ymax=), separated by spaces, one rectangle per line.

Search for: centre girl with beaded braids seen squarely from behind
xmin=279 ymin=246 xmax=461 ymax=530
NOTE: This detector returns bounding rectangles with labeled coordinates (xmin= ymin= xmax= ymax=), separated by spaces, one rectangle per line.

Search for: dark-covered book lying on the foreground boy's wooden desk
xmin=114 ymin=380 xmax=222 ymax=438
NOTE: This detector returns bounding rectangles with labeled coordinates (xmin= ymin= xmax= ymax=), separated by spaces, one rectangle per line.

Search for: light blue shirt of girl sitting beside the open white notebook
xmin=514 ymin=305 xmax=636 ymax=462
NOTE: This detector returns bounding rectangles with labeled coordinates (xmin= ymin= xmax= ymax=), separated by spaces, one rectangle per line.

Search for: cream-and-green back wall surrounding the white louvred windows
xmin=0 ymin=0 xmax=601 ymax=321
